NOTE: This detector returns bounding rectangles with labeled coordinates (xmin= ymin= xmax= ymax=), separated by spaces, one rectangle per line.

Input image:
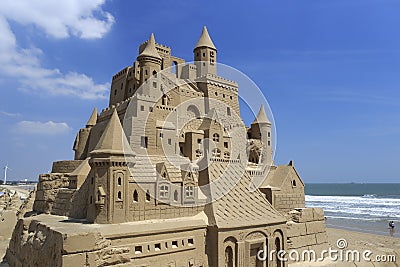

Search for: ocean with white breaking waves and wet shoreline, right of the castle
xmin=305 ymin=183 xmax=400 ymax=237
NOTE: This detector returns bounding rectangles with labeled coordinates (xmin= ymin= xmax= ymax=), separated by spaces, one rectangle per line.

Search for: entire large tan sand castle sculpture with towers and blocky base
xmin=6 ymin=27 xmax=327 ymax=267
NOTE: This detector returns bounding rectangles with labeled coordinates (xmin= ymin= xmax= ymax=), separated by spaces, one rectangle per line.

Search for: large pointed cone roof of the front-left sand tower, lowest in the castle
xmin=91 ymin=110 xmax=128 ymax=155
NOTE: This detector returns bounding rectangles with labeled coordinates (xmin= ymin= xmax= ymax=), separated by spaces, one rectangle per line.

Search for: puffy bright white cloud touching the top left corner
xmin=0 ymin=0 xmax=115 ymax=39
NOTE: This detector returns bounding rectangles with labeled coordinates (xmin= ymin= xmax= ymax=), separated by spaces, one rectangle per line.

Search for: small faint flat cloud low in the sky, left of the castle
xmin=15 ymin=121 xmax=72 ymax=135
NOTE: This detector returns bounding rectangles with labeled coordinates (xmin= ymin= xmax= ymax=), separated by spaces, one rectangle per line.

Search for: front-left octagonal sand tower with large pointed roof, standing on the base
xmin=87 ymin=110 xmax=131 ymax=223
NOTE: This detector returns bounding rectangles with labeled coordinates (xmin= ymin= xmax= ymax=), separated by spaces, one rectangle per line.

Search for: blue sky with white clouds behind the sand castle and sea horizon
xmin=0 ymin=0 xmax=400 ymax=183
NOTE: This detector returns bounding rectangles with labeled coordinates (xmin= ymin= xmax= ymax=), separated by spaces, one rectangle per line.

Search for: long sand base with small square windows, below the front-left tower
xmin=6 ymin=213 xmax=207 ymax=266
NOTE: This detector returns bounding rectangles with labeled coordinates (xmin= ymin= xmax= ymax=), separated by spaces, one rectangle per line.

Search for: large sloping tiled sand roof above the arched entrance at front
xmin=206 ymin=162 xmax=286 ymax=228
